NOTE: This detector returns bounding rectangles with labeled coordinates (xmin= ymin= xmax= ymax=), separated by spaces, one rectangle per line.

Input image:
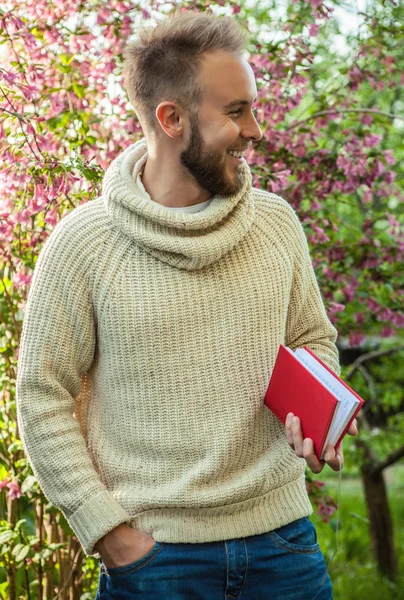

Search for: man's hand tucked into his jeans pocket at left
xmin=94 ymin=523 xmax=156 ymax=569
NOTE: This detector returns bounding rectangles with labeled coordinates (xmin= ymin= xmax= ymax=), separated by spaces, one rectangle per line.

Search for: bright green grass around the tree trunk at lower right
xmin=312 ymin=464 xmax=404 ymax=600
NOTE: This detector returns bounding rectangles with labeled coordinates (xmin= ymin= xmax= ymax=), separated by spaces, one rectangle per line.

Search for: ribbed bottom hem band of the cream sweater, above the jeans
xmin=130 ymin=477 xmax=313 ymax=543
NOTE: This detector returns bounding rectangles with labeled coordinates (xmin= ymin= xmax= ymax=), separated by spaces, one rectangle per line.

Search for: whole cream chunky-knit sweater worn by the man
xmin=17 ymin=140 xmax=339 ymax=554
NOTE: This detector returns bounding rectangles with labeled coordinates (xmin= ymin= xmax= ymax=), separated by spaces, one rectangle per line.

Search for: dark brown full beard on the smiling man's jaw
xmin=180 ymin=113 xmax=243 ymax=196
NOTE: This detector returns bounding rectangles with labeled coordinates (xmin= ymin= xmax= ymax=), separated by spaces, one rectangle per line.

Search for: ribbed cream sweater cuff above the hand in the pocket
xmin=68 ymin=491 xmax=132 ymax=556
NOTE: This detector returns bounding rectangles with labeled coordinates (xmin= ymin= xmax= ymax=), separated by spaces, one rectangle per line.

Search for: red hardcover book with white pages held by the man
xmin=264 ymin=345 xmax=364 ymax=458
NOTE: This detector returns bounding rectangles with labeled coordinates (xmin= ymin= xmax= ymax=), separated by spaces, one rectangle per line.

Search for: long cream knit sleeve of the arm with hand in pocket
xmin=16 ymin=213 xmax=131 ymax=554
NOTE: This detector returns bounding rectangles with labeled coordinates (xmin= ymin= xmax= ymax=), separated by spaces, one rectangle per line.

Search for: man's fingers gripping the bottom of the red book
xmin=285 ymin=413 xmax=358 ymax=473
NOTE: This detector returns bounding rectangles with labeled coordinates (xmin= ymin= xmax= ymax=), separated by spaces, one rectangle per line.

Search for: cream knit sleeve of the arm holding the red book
xmin=286 ymin=208 xmax=340 ymax=375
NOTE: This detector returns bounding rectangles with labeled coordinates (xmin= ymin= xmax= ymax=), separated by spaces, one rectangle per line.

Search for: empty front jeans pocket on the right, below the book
xmin=267 ymin=517 xmax=320 ymax=554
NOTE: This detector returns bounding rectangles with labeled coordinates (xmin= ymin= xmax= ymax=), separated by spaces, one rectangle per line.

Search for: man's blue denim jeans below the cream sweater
xmin=96 ymin=517 xmax=332 ymax=600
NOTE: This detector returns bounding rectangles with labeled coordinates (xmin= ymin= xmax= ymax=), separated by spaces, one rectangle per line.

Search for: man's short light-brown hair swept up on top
xmin=123 ymin=10 xmax=248 ymax=139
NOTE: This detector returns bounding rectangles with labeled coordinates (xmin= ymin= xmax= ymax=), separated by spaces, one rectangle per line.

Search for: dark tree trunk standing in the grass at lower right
xmin=361 ymin=462 xmax=397 ymax=581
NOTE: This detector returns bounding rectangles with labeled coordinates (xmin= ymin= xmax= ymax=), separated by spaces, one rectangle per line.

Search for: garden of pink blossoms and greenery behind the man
xmin=0 ymin=0 xmax=404 ymax=600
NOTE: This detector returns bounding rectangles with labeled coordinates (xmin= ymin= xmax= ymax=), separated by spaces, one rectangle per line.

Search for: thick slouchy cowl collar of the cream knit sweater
xmin=102 ymin=140 xmax=255 ymax=270
